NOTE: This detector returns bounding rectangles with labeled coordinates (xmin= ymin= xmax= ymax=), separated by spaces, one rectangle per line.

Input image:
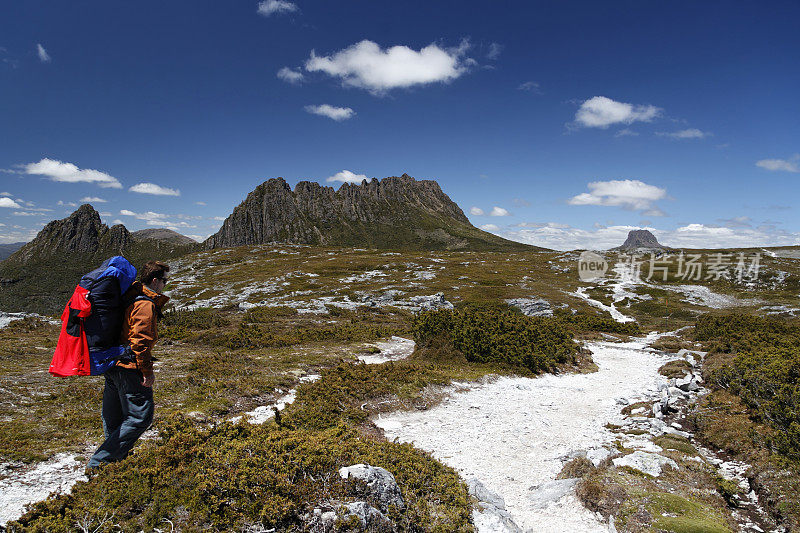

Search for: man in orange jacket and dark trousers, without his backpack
xmin=87 ymin=261 xmax=169 ymax=472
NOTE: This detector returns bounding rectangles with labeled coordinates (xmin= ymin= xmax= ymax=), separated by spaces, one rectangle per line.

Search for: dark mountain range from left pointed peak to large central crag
xmin=0 ymin=174 xmax=543 ymax=314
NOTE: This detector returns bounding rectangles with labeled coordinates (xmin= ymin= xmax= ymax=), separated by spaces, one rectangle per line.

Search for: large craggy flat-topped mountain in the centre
xmin=204 ymin=174 xmax=532 ymax=249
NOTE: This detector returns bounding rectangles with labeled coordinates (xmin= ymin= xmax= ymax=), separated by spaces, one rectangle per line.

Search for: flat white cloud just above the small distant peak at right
xmin=567 ymin=180 xmax=667 ymax=212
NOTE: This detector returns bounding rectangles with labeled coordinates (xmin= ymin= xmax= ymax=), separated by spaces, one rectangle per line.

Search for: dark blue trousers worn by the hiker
xmin=88 ymin=367 xmax=153 ymax=468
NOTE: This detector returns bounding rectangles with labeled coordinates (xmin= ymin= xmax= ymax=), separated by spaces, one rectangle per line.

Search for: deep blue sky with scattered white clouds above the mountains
xmin=0 ymin=0 xmax=800 ymax=249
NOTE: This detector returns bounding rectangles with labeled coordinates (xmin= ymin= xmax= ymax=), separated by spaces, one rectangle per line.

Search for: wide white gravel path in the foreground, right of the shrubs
xmin=375 ymin=334 xmax=668 ymax=533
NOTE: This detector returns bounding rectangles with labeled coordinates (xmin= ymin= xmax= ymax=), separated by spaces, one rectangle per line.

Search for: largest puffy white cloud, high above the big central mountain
xmin=305 ymin=40 xmax=475 ymax=94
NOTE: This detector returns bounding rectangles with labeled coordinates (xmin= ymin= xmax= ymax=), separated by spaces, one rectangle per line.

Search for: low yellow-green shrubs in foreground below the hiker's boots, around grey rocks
xmin=8 ymin=418 xmax=472 ymax=532
